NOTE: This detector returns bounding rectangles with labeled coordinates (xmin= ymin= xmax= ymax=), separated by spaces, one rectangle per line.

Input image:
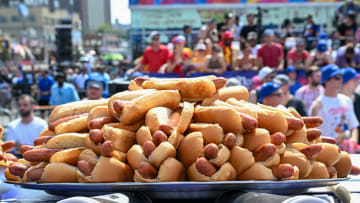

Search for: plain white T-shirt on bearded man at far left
xmin=6 ymin=117 xmax=47 ymax=145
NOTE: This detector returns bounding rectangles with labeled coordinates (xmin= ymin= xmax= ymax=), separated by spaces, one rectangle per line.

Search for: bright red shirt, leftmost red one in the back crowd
xmin=141 ymin=45 xmax=169 ymax=72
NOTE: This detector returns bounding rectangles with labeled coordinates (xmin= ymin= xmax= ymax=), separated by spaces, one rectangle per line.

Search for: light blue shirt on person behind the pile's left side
xmin=49 ymin=82 xmax=80 ymax=105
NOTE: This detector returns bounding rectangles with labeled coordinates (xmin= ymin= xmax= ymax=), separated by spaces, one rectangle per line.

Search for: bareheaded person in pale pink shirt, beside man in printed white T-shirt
xmin=295 ymin=66 xmax=324 ymax=112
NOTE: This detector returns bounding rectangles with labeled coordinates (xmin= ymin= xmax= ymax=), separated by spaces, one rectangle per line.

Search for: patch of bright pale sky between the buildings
xmin=111 ymin=0 xmax=131 ymax=24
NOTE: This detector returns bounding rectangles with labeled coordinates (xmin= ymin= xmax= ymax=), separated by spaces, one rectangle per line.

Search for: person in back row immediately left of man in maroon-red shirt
xmin=234 ymin=43 xmax=257 ymax=71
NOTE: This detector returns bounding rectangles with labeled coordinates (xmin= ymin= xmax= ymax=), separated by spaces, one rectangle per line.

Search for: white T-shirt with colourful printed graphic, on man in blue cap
xmin=310 ymin=94 xmax=359 ymax=142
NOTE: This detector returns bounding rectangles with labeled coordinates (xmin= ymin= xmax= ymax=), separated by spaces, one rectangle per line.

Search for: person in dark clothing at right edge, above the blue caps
xmin=335 ymin=45 xmax=360 ymax=68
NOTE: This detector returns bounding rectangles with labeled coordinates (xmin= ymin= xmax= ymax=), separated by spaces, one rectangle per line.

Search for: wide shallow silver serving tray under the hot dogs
xmin=5 ymin=178 xmax=350 ymax=199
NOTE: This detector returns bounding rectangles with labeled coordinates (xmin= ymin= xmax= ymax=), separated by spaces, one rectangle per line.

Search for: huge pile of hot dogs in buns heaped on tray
xmin=5 ymin=76 xmax=352 ymax=183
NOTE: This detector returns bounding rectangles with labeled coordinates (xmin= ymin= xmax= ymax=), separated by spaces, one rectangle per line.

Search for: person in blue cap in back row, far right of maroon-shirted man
xmin=310 ymin=41 xmax=333 ymax=68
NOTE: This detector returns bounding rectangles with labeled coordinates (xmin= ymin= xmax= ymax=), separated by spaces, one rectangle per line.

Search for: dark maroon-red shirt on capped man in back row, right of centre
xmin=257 ymin=43 xmax=284 ymax=68
